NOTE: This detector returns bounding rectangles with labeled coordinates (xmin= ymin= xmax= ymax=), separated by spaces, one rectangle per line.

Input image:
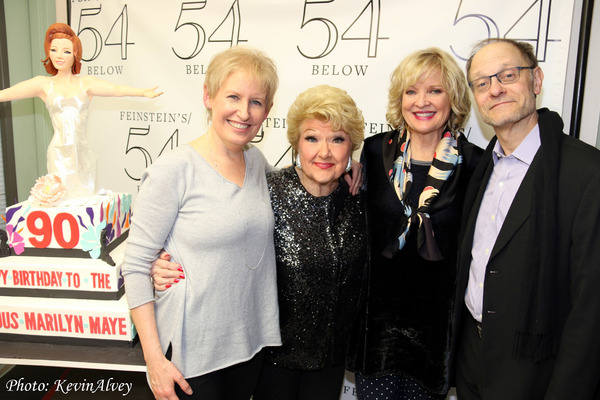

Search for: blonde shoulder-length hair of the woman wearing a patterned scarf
xmin=386 ymin=47 xmax=471 ymax=131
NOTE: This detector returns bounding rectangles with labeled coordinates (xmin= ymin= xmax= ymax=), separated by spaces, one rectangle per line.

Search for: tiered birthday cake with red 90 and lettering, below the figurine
xmin=0 ymin=193 xmax=135 ymax=345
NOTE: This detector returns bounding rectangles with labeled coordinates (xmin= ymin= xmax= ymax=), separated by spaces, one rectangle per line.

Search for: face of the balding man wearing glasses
xmin=468 ymin=42 xmax=543 ymax=132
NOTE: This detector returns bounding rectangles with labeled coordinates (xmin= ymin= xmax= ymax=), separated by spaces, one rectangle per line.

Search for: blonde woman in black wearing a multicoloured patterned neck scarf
xmin=349 ymin=48 xmax=481 ymax=400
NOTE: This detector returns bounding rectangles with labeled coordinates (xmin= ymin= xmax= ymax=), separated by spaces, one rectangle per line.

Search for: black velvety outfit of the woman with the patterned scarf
xmin=348 ymin=131 xmax=481 ymax=393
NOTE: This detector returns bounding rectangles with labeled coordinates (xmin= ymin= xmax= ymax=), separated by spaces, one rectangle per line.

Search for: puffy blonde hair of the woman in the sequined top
xmin=286 ymin=85 xmax=365 ymax=157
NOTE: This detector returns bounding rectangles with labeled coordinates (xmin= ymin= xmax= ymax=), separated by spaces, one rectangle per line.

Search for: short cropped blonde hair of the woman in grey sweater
xmin=204 ymin=46 xmax=279 ymax=118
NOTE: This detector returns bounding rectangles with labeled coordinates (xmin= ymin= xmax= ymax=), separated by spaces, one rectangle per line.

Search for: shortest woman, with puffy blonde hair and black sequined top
xmin=254 ymin=85 xmax=366 ymax=400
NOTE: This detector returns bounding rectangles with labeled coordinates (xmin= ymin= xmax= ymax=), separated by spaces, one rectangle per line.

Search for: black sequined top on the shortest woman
xmin=265 ymin=167 xmax=367 ymax=370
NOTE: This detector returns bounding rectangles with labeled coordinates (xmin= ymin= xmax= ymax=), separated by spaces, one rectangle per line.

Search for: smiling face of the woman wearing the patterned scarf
xmin=402 ymin=70 xmax=451 ymax=141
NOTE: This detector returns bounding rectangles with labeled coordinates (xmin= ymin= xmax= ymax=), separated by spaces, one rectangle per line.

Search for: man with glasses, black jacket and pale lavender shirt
xmin=454 ymin=39 xmax=600 ymax=400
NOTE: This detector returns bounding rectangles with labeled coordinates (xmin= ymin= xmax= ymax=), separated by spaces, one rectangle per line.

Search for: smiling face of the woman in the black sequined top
xmin=298 ymin=119 xmax=352 ymax=196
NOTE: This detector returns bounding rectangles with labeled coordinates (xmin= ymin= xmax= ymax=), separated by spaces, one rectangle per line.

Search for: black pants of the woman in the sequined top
xmin=253 ymin=363 xmax=346 ymax=400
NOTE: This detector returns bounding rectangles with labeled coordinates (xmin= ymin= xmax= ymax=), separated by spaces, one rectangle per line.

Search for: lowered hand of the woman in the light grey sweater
xmin=146 ymin=356 xmax=192 ymax=400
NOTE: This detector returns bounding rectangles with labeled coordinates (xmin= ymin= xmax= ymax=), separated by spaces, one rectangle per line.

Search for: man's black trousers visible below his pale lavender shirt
xmin=456 ymin=309 xmax=482 ymax=400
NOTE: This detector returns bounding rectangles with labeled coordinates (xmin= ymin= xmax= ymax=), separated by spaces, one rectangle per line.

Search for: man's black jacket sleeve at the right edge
xmin=545 ymin=171 xmax=600 ymax=400
